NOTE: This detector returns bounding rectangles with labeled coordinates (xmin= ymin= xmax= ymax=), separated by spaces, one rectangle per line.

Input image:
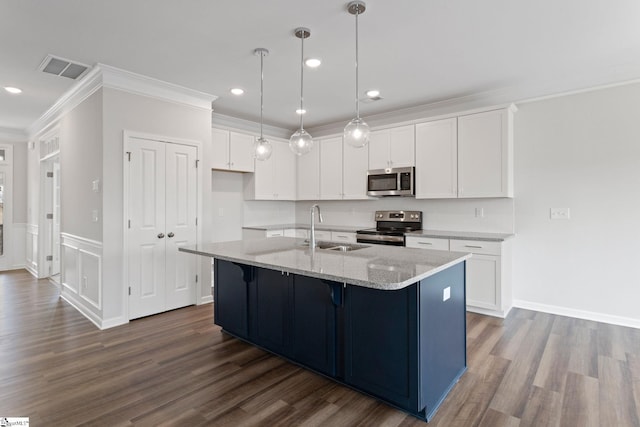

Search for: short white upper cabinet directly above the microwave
xmin=369 ymin=125 xmax=415 ymax=169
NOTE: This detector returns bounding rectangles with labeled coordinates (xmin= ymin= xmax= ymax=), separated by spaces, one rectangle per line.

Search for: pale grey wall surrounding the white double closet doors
xmin=102 ymin=88 xmax=212 ymax=319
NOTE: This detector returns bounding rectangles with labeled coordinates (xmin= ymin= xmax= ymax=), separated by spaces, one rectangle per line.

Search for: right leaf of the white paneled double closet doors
xmin=165 ymin=144 xmax=198 ymax=310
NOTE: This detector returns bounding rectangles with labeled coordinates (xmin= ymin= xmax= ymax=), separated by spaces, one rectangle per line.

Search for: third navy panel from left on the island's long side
xmin=291 ymin=275 xmax=342 ymax=376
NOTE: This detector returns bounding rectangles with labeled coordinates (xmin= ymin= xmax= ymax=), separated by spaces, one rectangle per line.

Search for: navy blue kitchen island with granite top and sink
xmin=180 ymin=237 xmax=470 ymax=421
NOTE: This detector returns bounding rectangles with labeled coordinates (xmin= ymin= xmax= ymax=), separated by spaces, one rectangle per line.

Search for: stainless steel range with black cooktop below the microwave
xmin=356 ymin=211 xmax=422 ymax=246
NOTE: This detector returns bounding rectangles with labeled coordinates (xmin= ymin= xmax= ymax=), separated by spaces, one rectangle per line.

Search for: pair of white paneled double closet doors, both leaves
xmin=128 ymin=138 xmax=198 ymax=319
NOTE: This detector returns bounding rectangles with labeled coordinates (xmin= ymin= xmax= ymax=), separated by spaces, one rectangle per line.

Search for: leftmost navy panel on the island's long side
xmin=218 ymin=259 xmax=254 ymax=338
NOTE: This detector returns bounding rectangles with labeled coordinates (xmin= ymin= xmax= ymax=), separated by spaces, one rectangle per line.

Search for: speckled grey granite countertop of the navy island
xmin=179 ymin=237 xmax=471 ymax=291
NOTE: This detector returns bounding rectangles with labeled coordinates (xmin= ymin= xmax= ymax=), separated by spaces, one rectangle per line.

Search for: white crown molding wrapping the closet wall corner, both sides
xmin=27 ymin=63 xmax=218 ymax=137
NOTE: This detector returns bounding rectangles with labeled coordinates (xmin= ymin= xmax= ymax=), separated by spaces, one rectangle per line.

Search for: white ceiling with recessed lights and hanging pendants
xmin=0 ymin=0 xmax=640 ymax=134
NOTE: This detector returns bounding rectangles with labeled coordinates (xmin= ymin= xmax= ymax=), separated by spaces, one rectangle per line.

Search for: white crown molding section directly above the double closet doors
xmin=96 ymin=63 xmax=218 ymax=111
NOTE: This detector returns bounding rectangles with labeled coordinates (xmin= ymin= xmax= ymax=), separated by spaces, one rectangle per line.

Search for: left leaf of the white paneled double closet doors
xmin=129 ymin=139 xmax=166 ymax=319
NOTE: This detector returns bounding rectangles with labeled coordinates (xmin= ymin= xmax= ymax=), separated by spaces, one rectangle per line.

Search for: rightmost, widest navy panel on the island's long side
xmin=344 ymin=284 xmax=420 ymax=413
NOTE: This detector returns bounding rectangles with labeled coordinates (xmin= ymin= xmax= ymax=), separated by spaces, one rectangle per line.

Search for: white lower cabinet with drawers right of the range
xmin=406 ymin=236 xmax=512 ymax=317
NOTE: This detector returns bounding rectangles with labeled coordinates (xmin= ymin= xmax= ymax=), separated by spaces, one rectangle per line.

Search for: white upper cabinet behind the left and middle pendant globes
xmin=245 ymin=138 xmax=296 ymax=200
